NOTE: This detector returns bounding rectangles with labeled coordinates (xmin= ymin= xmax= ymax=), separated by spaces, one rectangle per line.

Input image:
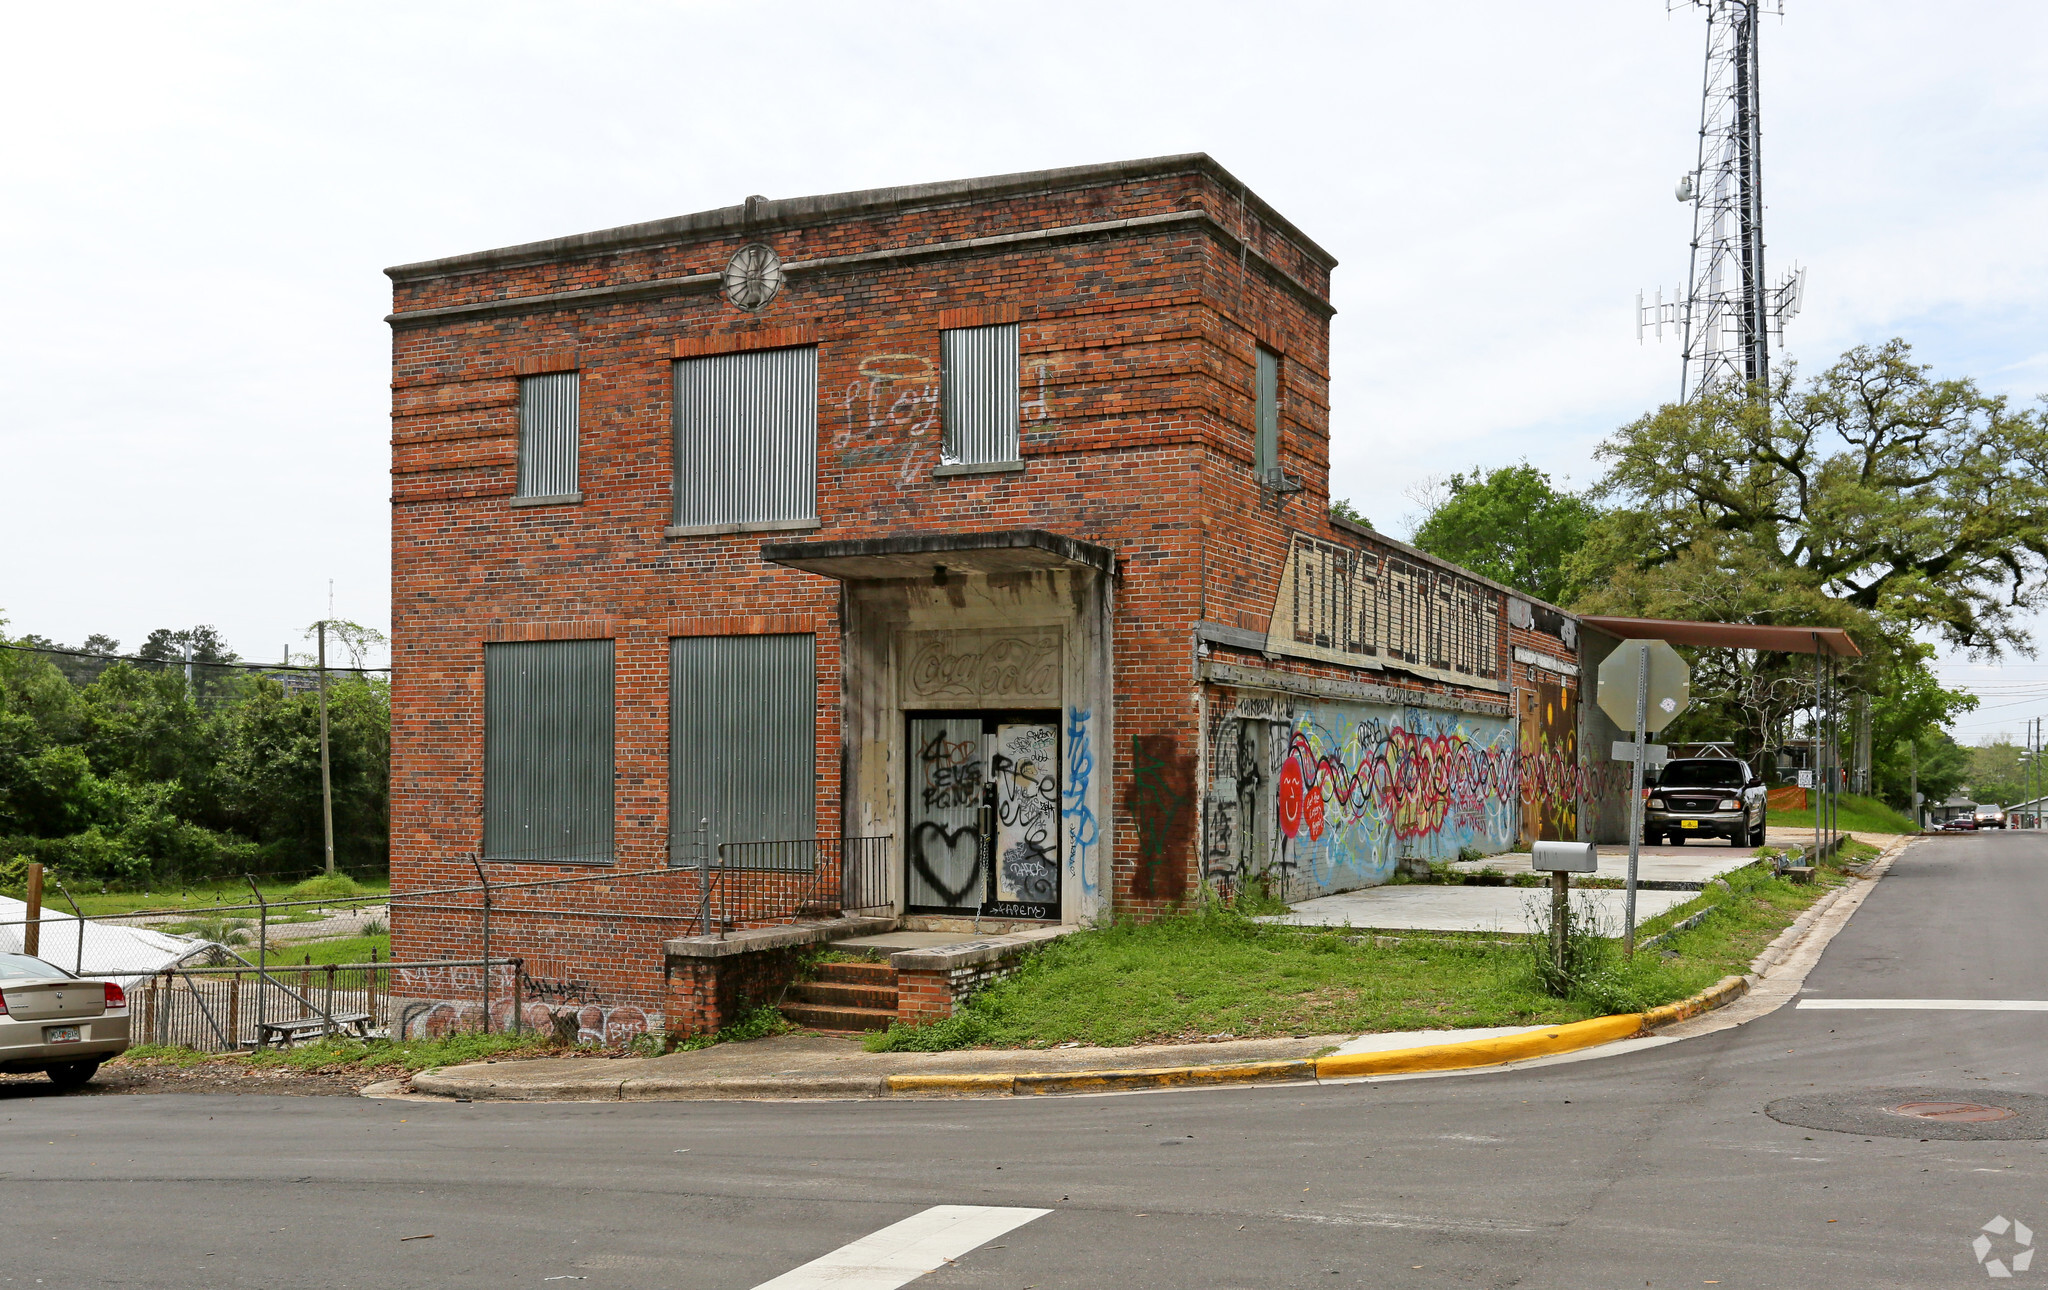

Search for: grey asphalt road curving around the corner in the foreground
xmin=0 ymin=833 xmax=2048 ymax=1290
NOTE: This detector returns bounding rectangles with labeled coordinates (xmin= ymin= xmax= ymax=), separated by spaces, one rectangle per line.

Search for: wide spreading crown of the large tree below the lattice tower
xmin=1587 ymin=340 xmax=2048 ymax=655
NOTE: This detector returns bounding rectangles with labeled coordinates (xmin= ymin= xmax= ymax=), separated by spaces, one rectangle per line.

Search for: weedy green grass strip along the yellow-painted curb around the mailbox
xmin=868 ymin=844 xmax=1876 ymax=1050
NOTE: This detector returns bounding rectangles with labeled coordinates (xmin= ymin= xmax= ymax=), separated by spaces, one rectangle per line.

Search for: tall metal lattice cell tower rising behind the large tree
xmin=1636 ymin=0 xmax=1806 ymax=401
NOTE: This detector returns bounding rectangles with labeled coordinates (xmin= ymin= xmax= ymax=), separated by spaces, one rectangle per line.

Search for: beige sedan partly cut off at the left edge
xmin=0 ymin=954 xmax=129 ymax=1089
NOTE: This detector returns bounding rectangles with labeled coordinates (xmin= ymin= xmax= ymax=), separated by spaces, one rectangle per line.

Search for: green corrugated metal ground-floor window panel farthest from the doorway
xmin=483 ymin=641 xmax=612 ymax=864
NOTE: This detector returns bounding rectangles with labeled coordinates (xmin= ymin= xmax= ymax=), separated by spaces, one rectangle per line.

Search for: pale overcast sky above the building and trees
xmin=0 ymin=0 xmax=2048 ymax=735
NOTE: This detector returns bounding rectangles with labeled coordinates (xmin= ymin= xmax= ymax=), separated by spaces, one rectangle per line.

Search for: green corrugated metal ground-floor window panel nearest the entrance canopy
xmin=668 ymin=635 xmax=817 ymax=862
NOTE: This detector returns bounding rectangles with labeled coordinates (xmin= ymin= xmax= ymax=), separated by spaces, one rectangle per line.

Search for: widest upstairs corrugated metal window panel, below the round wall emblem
xmin=676 ymin=346 xmax=817 ymax=526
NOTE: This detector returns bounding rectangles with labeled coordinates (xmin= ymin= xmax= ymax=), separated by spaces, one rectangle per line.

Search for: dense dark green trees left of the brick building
xmin=0 ymin=629 xmax=391 ymax=893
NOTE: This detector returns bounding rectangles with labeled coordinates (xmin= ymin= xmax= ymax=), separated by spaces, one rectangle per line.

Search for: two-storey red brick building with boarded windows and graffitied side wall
xmin=387 ymin=154 xmax=1581 ymax=1036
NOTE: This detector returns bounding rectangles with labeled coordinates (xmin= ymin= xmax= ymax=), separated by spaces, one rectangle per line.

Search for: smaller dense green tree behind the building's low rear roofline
xmin=1415 ymin=461 xmax=1595 ymax=602
